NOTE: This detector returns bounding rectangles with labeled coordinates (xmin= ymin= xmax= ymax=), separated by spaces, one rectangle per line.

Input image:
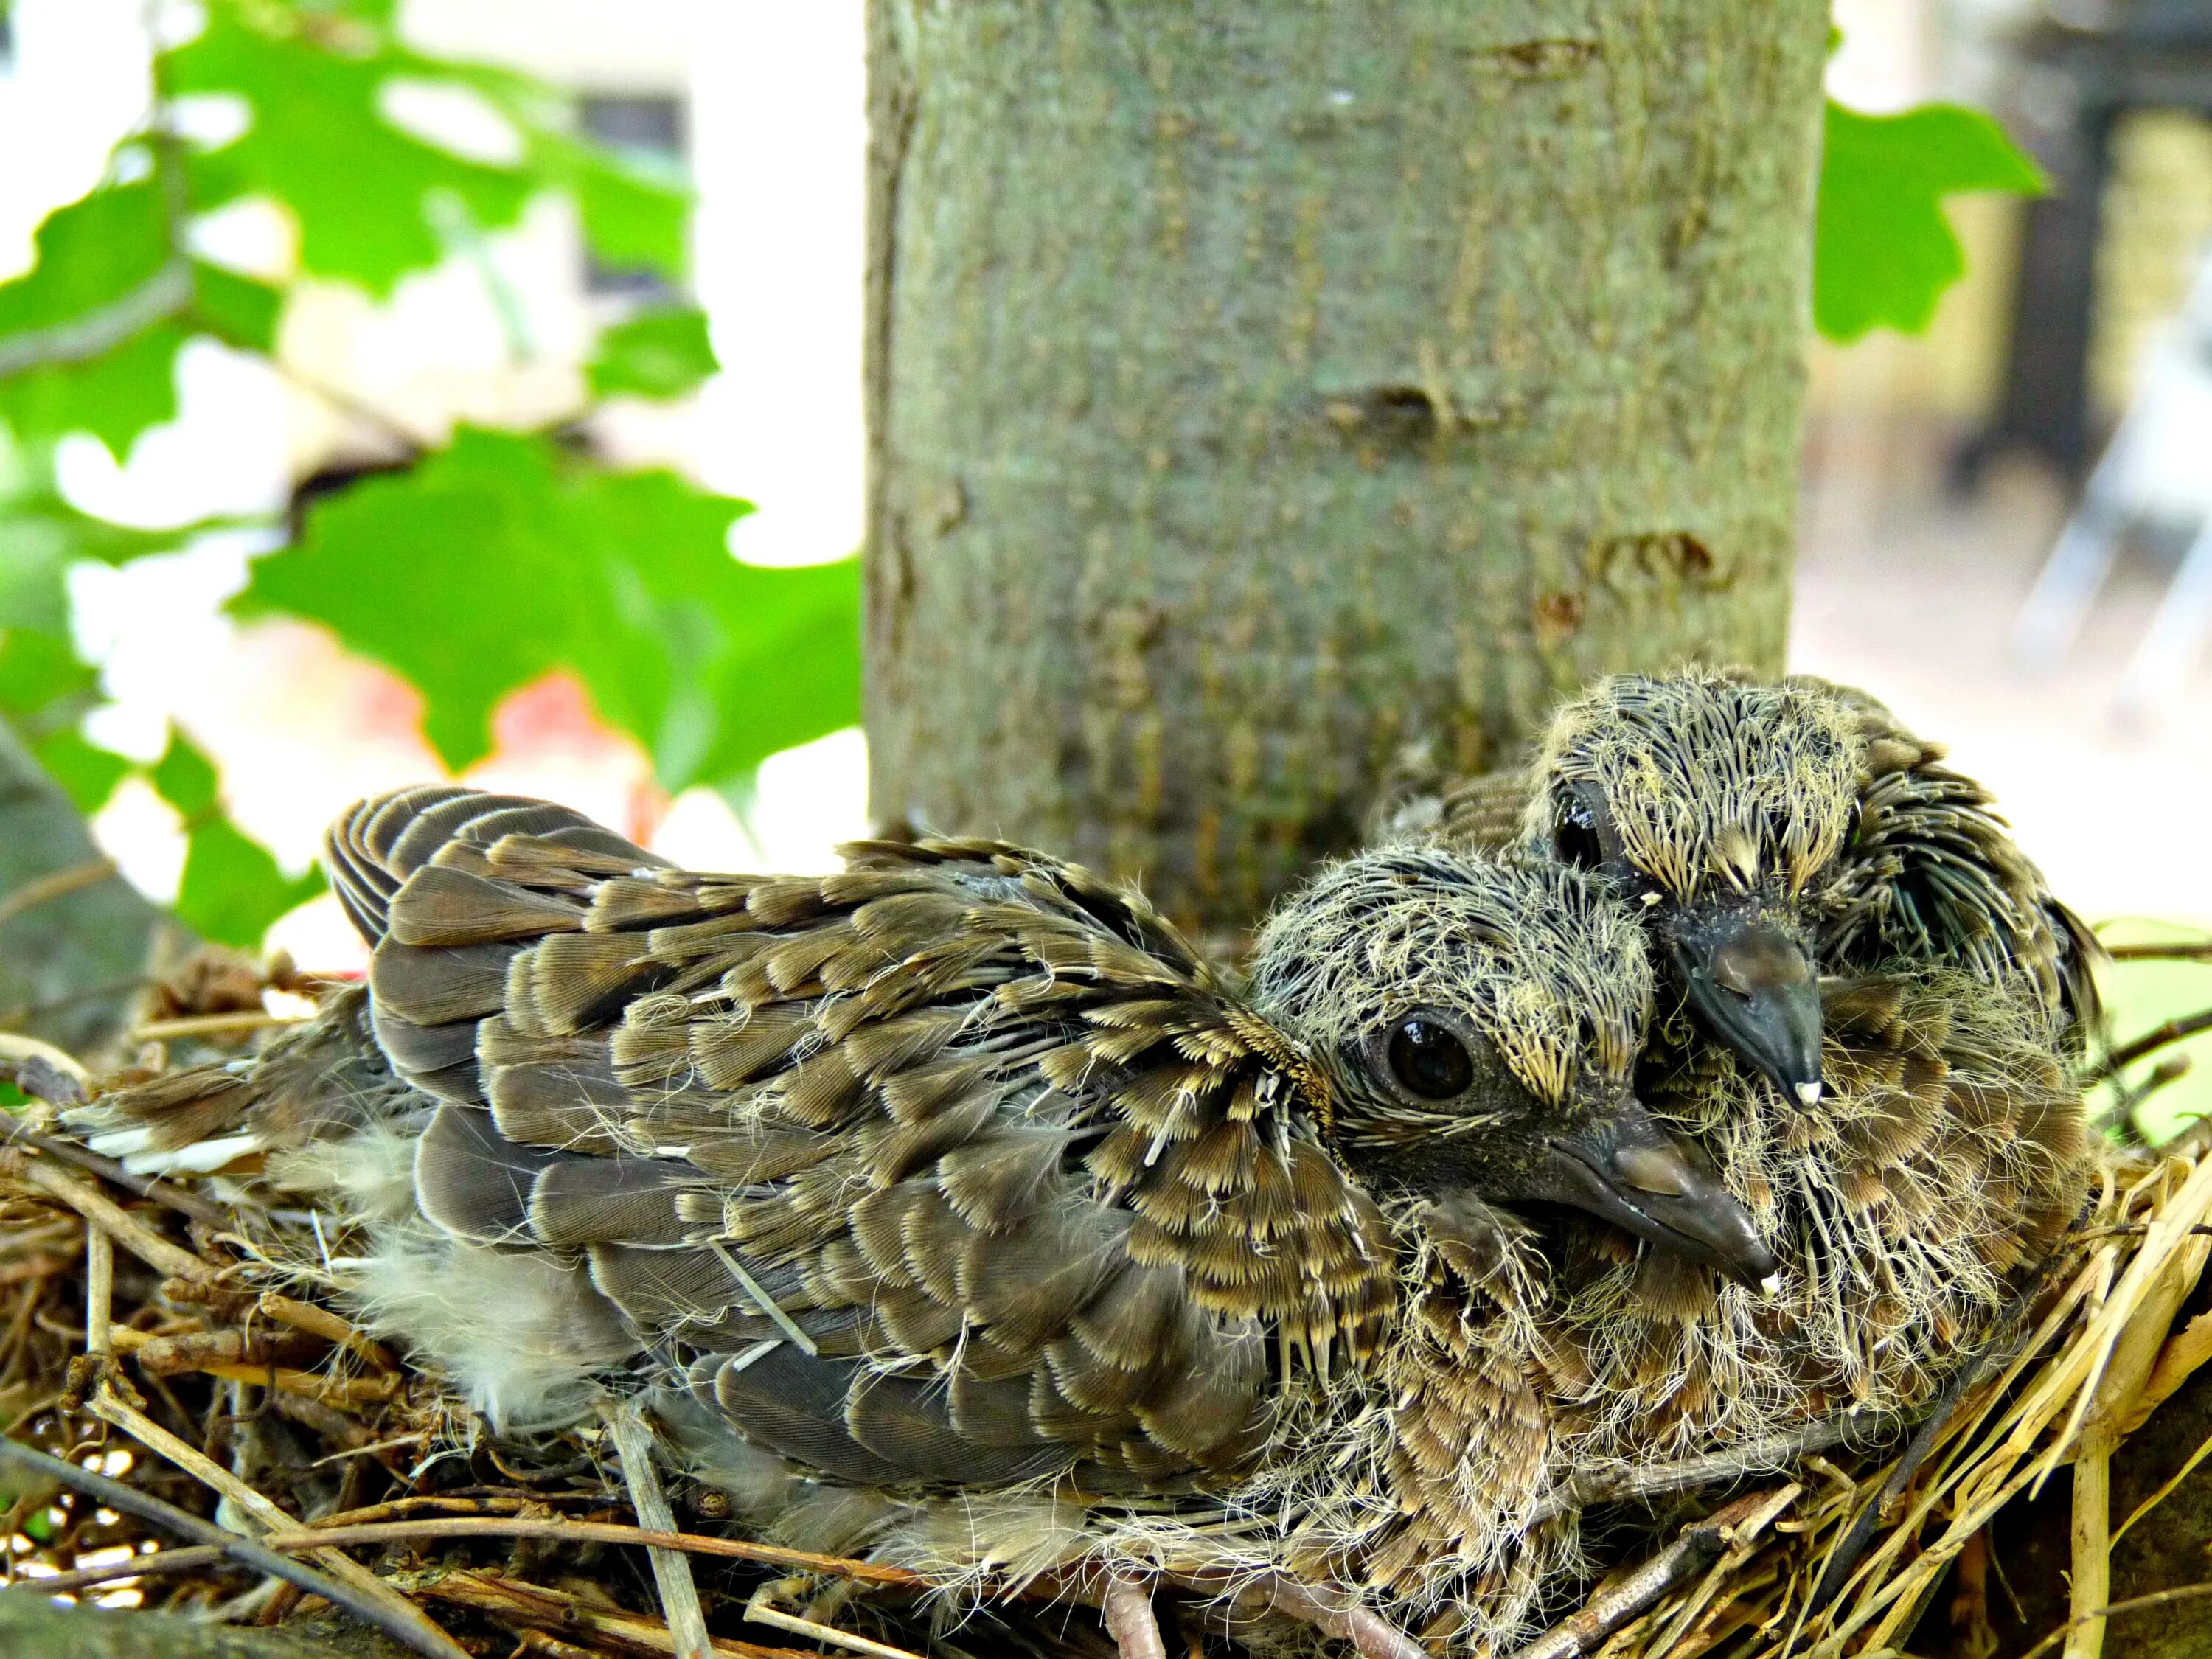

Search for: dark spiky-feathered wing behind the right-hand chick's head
xmin=1814 ymin=681 xmax=2099 ymax=1031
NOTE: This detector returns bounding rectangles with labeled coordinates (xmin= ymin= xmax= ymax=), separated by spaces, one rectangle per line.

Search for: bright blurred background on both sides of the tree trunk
xmin=0 ymin=0 xmax=2212 ymax=1110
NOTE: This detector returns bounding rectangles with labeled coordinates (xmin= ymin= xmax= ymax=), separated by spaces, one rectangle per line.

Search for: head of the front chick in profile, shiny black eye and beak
xmin=1252 ymin=847 xmax=1774 ymax=1283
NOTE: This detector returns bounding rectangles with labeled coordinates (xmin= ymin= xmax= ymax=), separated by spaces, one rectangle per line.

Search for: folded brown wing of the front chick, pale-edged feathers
xmin=334 ymin=796 xmax=1394 ymax=1484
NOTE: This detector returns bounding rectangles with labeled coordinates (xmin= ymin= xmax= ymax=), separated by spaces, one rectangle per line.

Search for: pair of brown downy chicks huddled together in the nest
xmin=56 ymin=675 xmax=2093 ymax=1639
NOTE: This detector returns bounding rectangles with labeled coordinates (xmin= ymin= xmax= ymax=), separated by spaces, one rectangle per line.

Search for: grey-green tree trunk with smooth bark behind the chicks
xmin=867 ymin=0 xmax=1827 ymax=927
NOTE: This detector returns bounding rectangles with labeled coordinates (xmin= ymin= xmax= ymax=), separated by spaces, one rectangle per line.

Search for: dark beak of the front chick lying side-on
xmin=1533 ymin=1097 xmax=1781 ymax=1285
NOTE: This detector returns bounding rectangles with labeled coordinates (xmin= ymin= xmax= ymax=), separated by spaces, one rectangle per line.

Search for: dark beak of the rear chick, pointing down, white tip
xmin=1674 ymin=911 xmax=1820 ymax=1106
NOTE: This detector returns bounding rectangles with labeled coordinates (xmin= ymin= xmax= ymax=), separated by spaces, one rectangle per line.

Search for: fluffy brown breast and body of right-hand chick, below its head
xmin=1542 ymin=969 xmax=2088 ymax=1475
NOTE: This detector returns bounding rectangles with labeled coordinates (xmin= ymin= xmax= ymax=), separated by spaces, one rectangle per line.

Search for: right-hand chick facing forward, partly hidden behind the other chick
xmin=1396 ymin=670 xmax=2095 ymax=1473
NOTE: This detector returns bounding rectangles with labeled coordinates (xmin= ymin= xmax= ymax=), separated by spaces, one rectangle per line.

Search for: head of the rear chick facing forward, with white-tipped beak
xmin=1522 ymin=670 xmax=1860 ymax=1106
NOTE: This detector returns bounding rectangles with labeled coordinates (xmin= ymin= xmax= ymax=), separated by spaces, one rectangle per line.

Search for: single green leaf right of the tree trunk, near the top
xmin=1812 ymin=102 xmax=2044 ymax=341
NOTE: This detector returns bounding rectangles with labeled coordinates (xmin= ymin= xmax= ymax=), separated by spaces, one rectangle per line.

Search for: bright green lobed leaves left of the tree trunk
xmin=0 ymin=0 xmax=858 ymax=960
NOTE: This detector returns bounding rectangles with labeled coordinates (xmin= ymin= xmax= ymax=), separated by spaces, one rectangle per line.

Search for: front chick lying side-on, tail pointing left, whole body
xmin=77 ymin=787 xmax=1776 ymax=1655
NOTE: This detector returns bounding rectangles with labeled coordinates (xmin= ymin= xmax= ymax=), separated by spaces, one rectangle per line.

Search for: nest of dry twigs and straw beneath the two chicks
xmin=0 ymin=973 xmax=2212 ymax=1659
